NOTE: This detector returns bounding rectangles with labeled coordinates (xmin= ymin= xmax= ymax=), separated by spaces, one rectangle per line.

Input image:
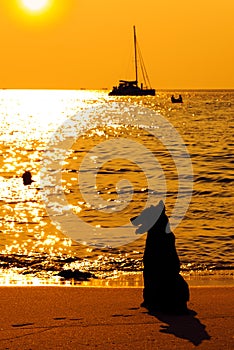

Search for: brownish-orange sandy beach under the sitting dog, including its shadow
xmin=0 ymin=286 xmax=234 ymax=350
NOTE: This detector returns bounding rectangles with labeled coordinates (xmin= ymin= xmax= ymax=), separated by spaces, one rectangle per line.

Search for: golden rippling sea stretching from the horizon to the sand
xmin=0 ymin=90 xmax=234 ymax=285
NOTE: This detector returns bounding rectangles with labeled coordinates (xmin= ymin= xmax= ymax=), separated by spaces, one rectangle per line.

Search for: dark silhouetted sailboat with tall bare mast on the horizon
xmin=109 ymin=26 xmax=155 ymax=96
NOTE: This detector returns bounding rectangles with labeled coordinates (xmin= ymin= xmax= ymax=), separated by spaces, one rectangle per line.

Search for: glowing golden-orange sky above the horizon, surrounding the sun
xmin=0 ymin=0 xmax=234 ymax=89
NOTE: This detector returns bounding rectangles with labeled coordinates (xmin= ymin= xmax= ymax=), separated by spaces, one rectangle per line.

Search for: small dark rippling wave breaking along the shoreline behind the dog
xmin=0 ymin=252 xmax=234 ymax=281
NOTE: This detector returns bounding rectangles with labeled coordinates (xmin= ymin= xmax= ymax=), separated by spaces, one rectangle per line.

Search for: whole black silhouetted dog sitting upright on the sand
xmin=131 ymin=201 xmax=189 ymax=314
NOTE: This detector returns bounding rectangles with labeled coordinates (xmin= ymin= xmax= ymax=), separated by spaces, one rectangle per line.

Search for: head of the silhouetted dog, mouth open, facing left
xmin=130 ymin=200 xmax=170 ymax=234
